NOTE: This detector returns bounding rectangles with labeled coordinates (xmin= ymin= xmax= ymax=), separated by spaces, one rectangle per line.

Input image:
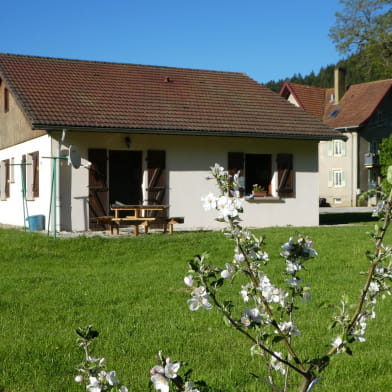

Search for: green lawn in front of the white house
xmin=0 ymin=223 xmax=392 ymax=392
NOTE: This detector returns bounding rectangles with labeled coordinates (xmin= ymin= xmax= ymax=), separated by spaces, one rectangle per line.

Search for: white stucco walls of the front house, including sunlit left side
xmin=0 ymin=132 xmax=319 ymax=231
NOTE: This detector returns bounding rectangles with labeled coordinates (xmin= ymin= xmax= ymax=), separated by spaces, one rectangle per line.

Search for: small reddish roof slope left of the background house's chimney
xmin=280 ymin=82 xmax=325 ymax=121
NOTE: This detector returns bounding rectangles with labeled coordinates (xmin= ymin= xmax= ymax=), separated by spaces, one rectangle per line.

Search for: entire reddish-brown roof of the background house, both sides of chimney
xmin=280 ymin=79 xmax=392 ymax=129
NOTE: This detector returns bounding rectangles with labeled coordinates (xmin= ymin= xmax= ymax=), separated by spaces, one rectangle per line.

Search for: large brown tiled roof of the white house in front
xmin=0 ymin=54 xmax=338 ymax=140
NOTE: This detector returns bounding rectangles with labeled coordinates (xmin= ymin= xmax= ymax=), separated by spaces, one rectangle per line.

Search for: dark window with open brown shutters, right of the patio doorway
xmin=228 ymin=152 xmax=294 ymax=197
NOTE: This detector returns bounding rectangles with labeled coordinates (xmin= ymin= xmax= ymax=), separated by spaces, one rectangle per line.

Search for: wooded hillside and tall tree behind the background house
xmin=265 ymin=0 xmax=392 ymax=93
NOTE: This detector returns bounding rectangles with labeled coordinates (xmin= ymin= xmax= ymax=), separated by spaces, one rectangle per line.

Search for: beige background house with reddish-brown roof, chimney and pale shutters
xmin=280 ymin=69 xmax=392 ymax=207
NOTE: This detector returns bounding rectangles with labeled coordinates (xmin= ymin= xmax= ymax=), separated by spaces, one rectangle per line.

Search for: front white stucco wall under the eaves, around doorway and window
xmin=46 ymin=132 xmax=319 ymax=231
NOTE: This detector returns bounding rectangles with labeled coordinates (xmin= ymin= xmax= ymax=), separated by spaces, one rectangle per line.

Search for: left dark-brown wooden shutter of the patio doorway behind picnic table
xmin=88 ymin=149 xmax=109 ymax=230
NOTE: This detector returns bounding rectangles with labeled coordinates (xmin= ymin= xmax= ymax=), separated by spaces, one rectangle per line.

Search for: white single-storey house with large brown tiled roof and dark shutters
xmin=0 ymin=54 xmax=341 ymax=231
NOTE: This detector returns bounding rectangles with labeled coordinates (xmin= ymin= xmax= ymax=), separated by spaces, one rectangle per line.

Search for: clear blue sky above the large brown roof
xmin=0 ymin=0 xmax=342 ymax=83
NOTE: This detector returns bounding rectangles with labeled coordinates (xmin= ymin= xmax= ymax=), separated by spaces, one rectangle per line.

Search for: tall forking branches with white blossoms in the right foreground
xmin=184 ymin=164 xmax=392 ymax=392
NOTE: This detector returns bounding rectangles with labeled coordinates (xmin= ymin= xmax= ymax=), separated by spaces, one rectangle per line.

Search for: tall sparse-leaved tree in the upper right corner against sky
xmin=329 ymin=0 xmax=392 ymax=78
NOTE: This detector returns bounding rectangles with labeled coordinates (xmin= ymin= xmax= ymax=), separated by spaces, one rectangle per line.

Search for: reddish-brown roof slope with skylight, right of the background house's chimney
xmin=323 ymin=79 xmax=392 ymax=128
